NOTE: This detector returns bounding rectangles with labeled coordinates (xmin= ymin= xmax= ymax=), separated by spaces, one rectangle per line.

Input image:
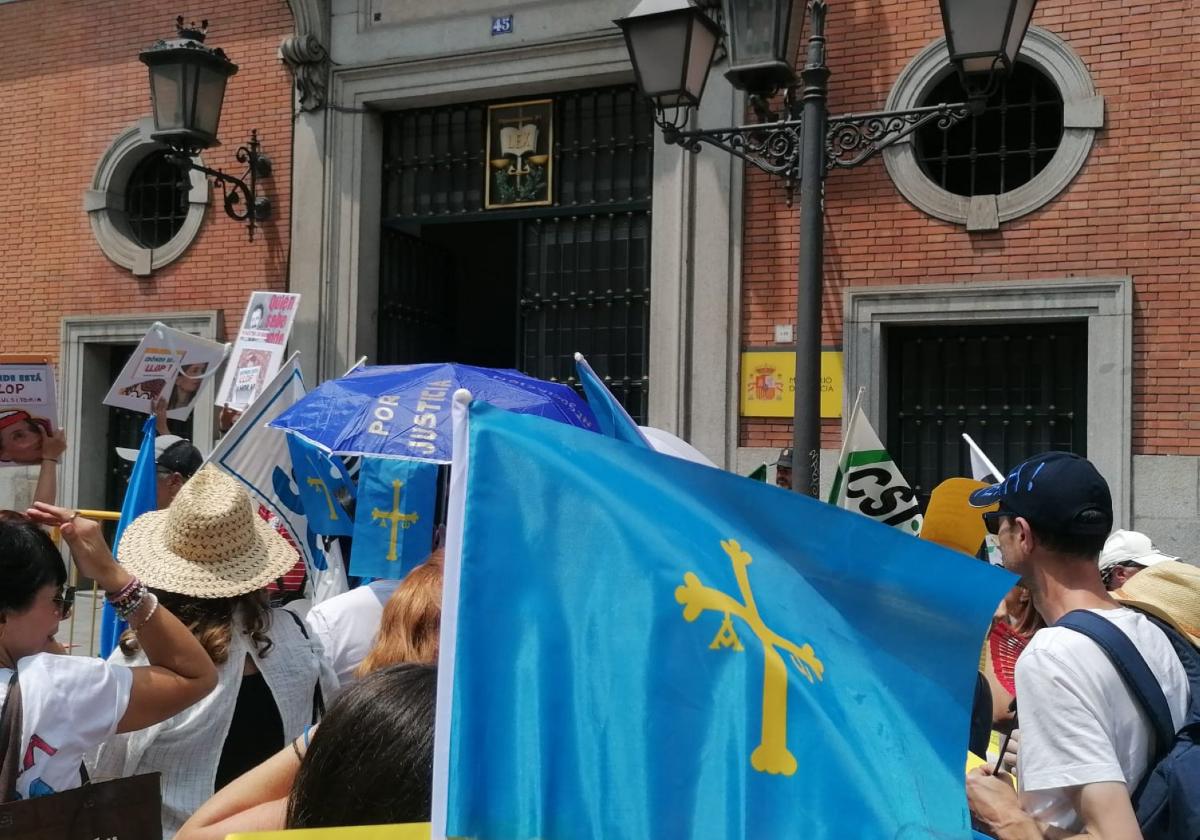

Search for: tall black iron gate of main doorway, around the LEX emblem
xmin=378 ymin=86 xmax=654 ymax=422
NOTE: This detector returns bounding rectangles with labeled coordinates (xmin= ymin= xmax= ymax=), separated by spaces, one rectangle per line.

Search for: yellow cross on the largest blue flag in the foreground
xmin=676 ymin=540 xmax=824 ymax=776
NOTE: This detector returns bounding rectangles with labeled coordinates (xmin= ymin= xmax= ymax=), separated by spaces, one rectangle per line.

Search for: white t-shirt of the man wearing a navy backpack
xmin=1016 ymin=607 xmax=1189 ymax=832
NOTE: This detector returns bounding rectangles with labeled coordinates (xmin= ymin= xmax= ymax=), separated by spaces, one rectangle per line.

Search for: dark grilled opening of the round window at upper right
xmin=916 ymin=61 xmax=1063 ymax=197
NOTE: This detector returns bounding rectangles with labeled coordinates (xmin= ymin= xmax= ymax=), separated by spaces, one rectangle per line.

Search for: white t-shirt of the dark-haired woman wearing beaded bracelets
xmin=0 ymin=653 xmax=133 ymax=799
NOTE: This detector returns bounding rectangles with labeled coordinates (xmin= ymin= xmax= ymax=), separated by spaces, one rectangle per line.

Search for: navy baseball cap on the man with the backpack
xmin=968 ymin=452 xmax=1112 ymax=536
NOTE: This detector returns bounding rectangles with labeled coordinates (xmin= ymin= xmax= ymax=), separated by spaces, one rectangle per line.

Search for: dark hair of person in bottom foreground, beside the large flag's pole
xmin=287 ymin=665 xmax=438 ymax=828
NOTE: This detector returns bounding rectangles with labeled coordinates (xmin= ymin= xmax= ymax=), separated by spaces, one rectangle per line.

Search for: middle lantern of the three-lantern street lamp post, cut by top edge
xmin=721 ymin=0 xmax=798 ymax=96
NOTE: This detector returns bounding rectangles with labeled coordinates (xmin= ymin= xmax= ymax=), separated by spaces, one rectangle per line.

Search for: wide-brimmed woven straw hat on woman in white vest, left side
xmin=118 ymin=466 xmax=298 ymax=598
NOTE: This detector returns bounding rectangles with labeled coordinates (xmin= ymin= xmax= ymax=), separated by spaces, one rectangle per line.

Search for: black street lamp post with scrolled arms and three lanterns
xmin=616 ymin=0 xmax=1037 ymax=497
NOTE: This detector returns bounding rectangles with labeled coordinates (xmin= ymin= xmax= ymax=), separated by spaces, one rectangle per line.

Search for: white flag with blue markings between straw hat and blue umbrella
xmin=209 ymin=353 xmax=347 ymax=604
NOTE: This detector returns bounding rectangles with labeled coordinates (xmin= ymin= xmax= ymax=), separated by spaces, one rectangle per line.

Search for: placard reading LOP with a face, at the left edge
xmin=0 ymin=355 xmax=58 ymax=467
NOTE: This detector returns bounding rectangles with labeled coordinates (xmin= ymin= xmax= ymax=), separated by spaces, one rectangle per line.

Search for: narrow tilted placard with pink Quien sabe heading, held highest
xmin=216 ymin=292 xmax=300 ymax=410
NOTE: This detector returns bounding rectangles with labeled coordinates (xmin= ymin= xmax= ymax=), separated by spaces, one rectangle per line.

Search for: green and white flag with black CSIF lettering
xmin=829 ymin=401 xmax=923 ymax=534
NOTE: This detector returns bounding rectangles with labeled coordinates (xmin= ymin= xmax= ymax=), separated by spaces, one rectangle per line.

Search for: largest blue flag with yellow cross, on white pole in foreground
xmin=432 ymin=392 xmax=1014 ymax=840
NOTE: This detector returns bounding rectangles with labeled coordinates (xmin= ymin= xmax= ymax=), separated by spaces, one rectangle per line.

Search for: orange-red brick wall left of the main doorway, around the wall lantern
xmin=0 ymin=0 xmax=294 ymax=358
